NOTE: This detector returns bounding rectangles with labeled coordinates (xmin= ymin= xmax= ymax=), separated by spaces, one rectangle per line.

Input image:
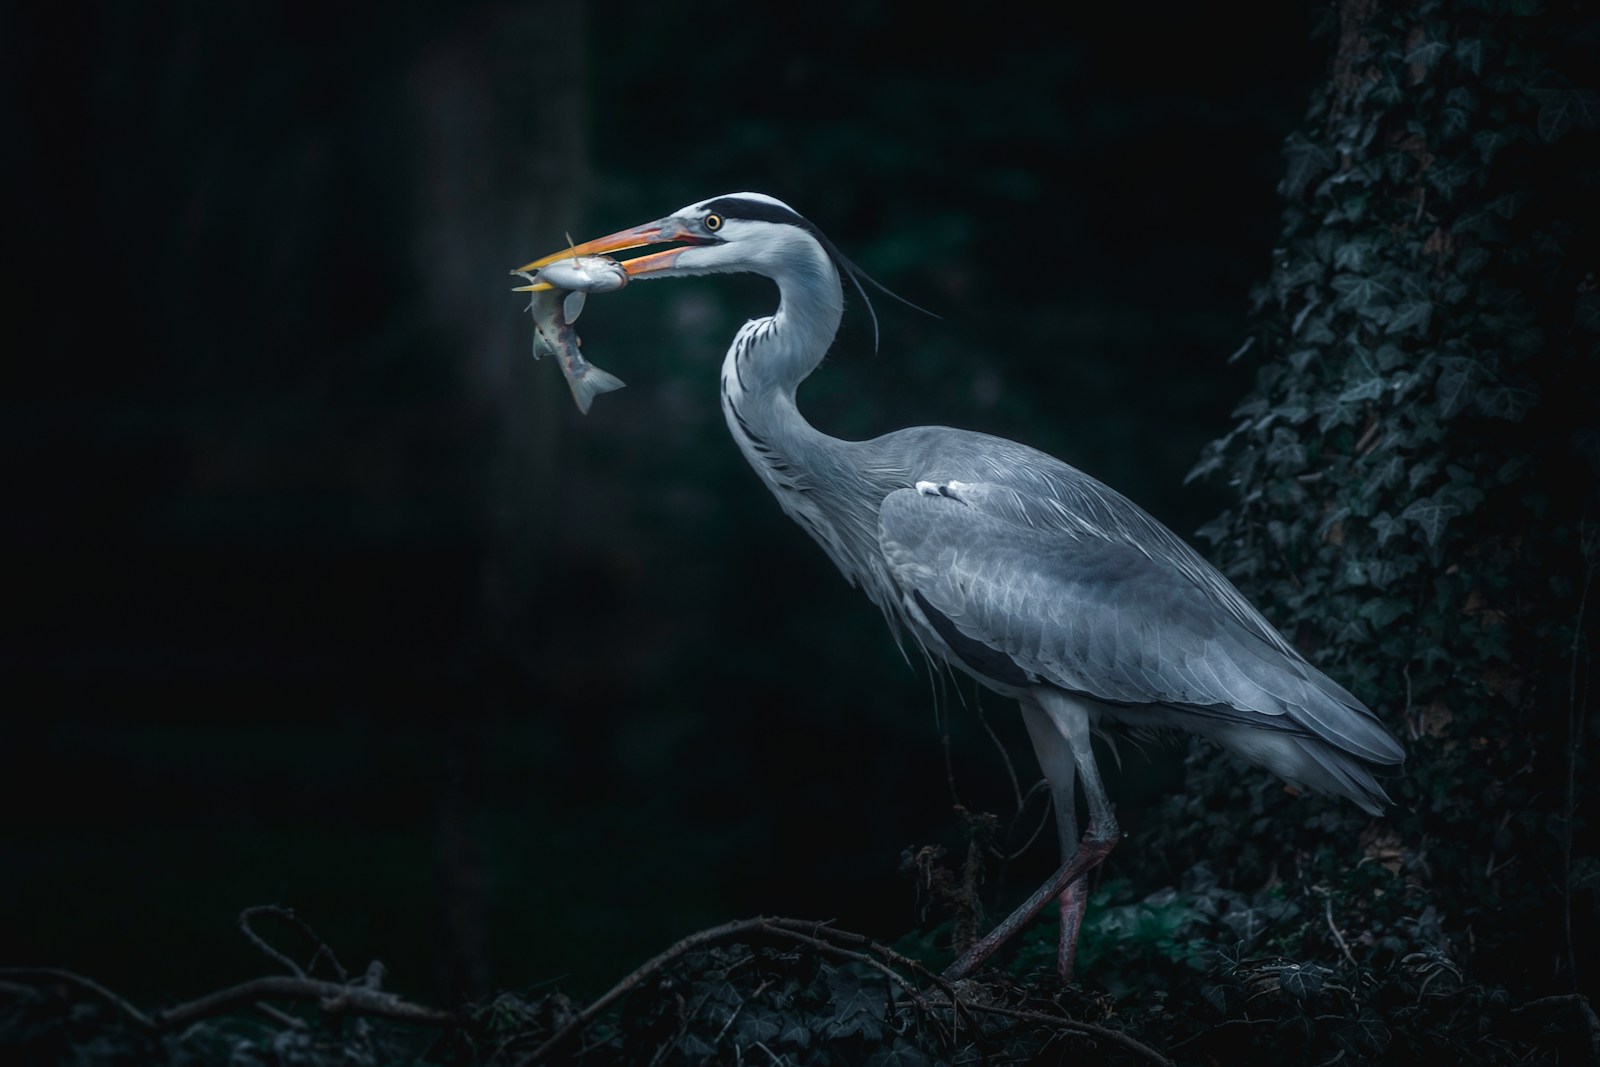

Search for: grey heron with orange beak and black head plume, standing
xmin=520 ymin=192 xmax=1405 ymax=977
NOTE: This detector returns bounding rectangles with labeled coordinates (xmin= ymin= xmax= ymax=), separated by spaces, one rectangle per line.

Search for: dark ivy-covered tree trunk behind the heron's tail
xmin=1171 ymin=0 xmax=1600 ymax=998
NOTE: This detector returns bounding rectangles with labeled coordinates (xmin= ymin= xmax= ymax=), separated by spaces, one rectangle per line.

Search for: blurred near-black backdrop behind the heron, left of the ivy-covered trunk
xmin=0 ymin=0 xmax=1325 ymax=997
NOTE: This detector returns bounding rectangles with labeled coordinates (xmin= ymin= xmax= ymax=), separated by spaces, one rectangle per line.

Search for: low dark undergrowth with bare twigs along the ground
xmin=0 ymin=940 xmax=1594 ymax=1067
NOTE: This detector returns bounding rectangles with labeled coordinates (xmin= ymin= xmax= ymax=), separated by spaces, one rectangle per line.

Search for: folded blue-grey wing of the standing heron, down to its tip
xmin=878 ymin=482 xmax=1403 ymax=767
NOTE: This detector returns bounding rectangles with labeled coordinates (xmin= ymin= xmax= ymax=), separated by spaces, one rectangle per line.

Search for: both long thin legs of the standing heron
xmin=944 ymin=689 xmax=1118 ymax=981
